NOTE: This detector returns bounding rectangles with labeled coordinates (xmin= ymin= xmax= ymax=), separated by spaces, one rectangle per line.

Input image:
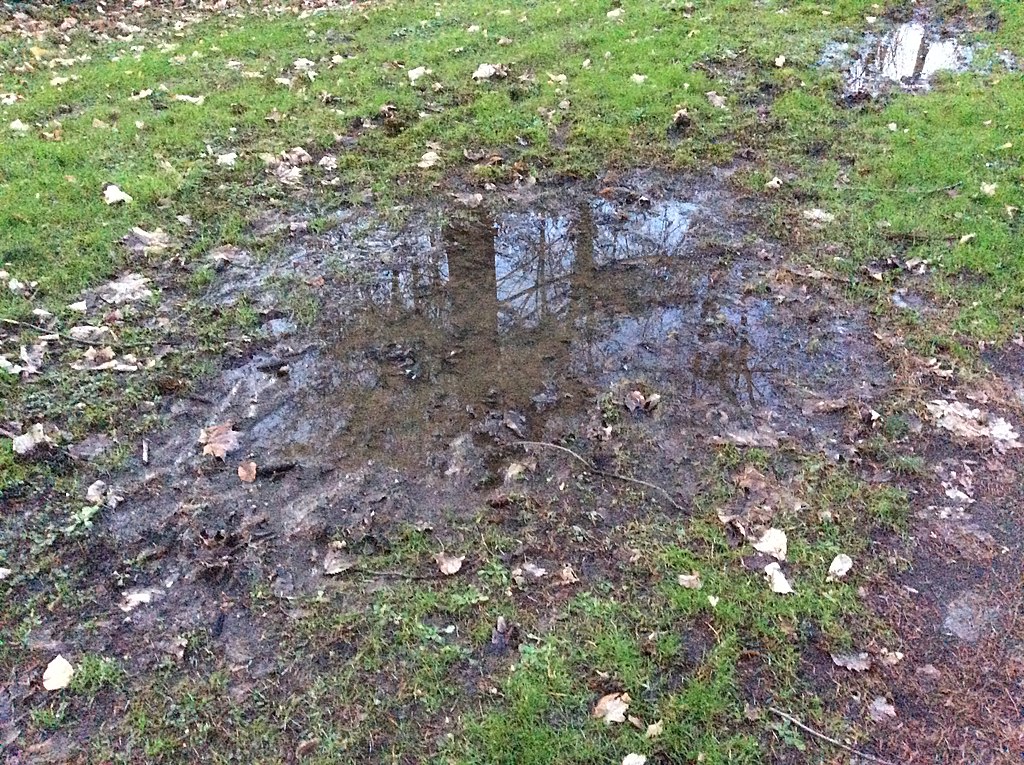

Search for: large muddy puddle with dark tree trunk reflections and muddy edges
xmin=99 ymin=176 xmax=889 ymax=659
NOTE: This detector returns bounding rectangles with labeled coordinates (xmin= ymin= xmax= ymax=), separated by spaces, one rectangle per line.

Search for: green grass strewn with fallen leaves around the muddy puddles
xmin=0 ymin=0 xmax=1024 ymax=765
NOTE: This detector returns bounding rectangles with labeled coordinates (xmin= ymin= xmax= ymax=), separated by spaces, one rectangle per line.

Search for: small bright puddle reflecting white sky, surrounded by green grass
xmin=822 ymin=16 xmax=1014 ymax=98
